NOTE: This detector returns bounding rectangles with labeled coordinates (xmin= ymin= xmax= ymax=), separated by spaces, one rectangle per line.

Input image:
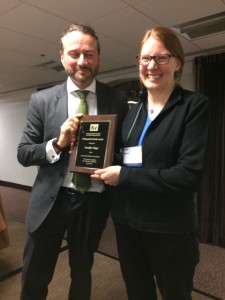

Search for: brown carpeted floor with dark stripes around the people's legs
xmin=0 ymin=186 xmax=225 ymax=300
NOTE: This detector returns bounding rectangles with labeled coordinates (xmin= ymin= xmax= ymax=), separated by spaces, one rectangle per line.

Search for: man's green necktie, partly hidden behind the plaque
xmin=72 ymin=91 xmax=91 ymax=194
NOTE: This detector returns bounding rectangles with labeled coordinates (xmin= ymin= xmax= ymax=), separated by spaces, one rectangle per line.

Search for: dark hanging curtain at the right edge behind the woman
xmin=194 ymin=53 xmax=225 ymax=247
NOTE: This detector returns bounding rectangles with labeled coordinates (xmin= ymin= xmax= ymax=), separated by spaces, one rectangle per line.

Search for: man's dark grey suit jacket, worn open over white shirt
xmin=17 ymin=81 xmax=128 ymax=232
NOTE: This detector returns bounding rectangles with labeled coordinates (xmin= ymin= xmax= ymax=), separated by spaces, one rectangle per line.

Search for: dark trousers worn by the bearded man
xmin=20 ymin=189 xmax=110 ymax=300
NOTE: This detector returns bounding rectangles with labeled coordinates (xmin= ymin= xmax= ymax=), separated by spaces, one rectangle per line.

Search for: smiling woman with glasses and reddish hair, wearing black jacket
xmin=93 ymin=28 xmax=208 ymax=300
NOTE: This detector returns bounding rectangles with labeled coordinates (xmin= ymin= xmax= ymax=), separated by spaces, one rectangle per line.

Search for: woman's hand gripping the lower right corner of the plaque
xmin=91 ymin=166 xmax=121 ymax=186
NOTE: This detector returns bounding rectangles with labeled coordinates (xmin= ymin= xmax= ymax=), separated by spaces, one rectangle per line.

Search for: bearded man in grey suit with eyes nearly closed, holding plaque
xmin=18 ymin=24 xmax=128 ymax=300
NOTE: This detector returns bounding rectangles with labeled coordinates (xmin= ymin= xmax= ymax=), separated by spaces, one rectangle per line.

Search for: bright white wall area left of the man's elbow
xmin=0 ymin=90 xmax=36 ymax=186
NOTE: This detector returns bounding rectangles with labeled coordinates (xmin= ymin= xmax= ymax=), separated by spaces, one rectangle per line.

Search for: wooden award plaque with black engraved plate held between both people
xmin=70 ymin=115 xmax=118 ymax=174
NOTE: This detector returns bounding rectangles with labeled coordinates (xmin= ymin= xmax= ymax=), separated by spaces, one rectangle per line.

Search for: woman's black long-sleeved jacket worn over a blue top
xmin=112 ymin=86 xmax=208 ymax=233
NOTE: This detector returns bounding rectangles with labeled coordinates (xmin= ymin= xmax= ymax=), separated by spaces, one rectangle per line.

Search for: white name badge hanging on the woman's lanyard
xmin=123 ymin=146 xmax=142 ymax=167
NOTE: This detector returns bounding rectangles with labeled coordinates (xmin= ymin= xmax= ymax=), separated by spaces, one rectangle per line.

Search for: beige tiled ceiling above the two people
xmin=0 ymin=0 xmax=225 ymax=99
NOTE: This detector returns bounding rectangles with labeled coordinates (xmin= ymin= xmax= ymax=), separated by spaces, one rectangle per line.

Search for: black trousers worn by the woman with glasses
xmin=114 ymin=222 xmax=199 ymax=300
